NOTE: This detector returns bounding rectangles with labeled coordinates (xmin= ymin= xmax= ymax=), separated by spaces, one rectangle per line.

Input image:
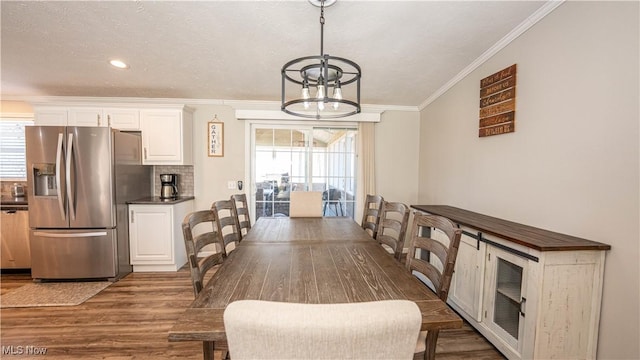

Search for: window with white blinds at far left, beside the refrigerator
xmin=0 ymin=117 xmax=33 ymax=180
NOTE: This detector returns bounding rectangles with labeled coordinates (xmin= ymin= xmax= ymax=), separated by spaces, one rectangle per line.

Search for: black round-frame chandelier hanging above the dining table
xmin=280 ymin=0 xmax=362 ymax=119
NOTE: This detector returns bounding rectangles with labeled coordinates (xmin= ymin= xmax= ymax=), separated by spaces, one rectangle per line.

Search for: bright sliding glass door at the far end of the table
xmin=251 ymin=124 xmax=357 ymax=220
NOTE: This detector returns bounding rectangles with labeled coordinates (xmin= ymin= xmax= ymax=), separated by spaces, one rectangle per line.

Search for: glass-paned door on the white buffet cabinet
xmin=484 ymin=246 xmax=528 ymax=353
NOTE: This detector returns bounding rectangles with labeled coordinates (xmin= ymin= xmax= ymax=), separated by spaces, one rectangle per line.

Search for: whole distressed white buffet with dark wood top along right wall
xmin=413 ymin=205 xmax=610 ymax=360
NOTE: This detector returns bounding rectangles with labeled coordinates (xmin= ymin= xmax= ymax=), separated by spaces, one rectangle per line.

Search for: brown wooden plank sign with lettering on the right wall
xmin=478 ymin=64 xmax=516 ymax=137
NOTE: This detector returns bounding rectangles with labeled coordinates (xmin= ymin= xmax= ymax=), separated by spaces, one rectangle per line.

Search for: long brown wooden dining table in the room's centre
xmin=169 ymin=217 xmax=462 ymax=358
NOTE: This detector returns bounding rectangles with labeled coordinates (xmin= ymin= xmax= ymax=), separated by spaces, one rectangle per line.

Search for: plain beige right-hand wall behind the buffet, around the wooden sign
xmin=419 ymin=2 xmax=640 ymax=359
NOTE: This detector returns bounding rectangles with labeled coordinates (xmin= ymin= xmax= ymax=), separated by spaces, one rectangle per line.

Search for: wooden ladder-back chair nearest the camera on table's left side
xmin=182 ymin=210 xmax=228 ymax=358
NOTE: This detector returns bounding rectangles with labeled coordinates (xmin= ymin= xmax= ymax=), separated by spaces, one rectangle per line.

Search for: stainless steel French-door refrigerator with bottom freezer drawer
xmin=25 ymin=126 xmax=151 ymax=281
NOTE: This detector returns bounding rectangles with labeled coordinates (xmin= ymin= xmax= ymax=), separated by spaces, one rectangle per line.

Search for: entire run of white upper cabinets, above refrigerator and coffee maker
xmin=32 ymin=101 xmax=193 ymax=165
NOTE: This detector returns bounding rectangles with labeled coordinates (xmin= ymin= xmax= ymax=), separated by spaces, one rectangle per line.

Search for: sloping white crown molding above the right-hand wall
xmin=418 ymin=0 xmax=565 ymax=111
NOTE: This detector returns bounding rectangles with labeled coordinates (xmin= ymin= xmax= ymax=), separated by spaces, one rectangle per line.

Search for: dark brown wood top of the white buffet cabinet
xmin=411 ymin=205 xmax=611 ymax=251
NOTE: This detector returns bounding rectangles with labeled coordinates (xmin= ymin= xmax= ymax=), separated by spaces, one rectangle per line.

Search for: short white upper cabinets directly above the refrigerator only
xmin=34 ymin=106 xmax=140 ymax=131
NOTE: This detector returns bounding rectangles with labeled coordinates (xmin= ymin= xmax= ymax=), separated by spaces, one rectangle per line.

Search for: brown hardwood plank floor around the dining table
xmin=0 ymin=269 xmax=504 ymax=360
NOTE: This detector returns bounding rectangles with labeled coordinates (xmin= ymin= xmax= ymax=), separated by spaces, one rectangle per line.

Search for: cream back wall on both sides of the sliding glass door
xmin=189 ymin=105 xmax=420 ymax=217
